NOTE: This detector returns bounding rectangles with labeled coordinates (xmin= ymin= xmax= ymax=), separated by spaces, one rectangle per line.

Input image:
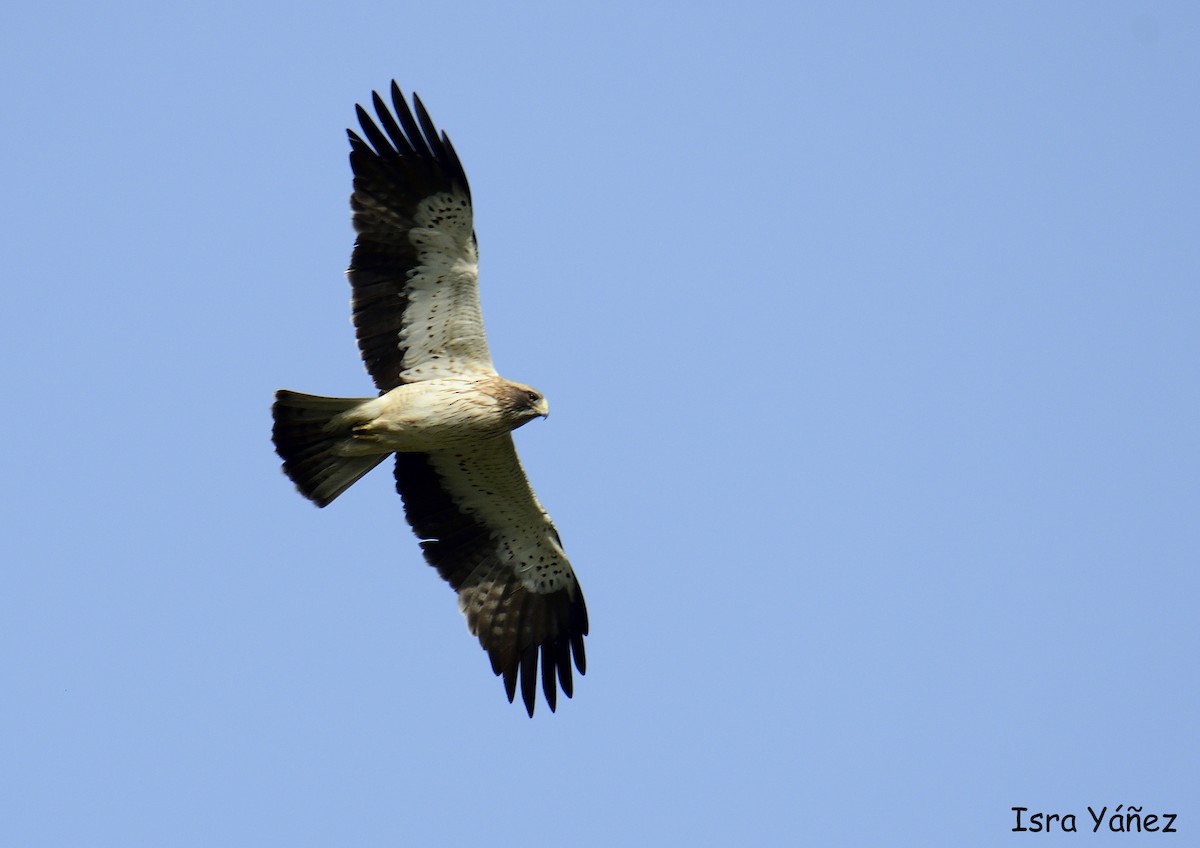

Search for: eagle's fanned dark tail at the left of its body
xmin=271 ymin=389 xmax=388 ymax=506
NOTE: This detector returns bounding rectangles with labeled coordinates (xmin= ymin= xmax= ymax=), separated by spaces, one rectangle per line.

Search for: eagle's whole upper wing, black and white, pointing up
xmin=346 ymin=82 xmax=496 ymax=392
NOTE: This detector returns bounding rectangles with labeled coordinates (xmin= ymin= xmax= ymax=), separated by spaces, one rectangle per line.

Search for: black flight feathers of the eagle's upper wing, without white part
xmin=346 ymin=82 xmax=470 ymax=392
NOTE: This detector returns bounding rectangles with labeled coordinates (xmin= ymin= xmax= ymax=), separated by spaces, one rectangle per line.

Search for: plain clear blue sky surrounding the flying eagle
xmin=0 ymin=0 xmax=1200 ymax=848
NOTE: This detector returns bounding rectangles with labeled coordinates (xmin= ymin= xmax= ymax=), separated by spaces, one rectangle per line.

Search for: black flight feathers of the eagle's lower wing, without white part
xmin=396 ymin=453 xmax=588 ymax=716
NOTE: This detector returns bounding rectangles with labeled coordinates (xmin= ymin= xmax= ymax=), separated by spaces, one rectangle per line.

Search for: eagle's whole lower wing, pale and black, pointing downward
xmin=396 ymin=435 xmax=588 ymax=716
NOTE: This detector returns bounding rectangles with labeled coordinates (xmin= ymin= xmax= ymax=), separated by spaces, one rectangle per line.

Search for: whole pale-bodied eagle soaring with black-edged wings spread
xmin=271 ymin=82 xmax=588 ymax=716
